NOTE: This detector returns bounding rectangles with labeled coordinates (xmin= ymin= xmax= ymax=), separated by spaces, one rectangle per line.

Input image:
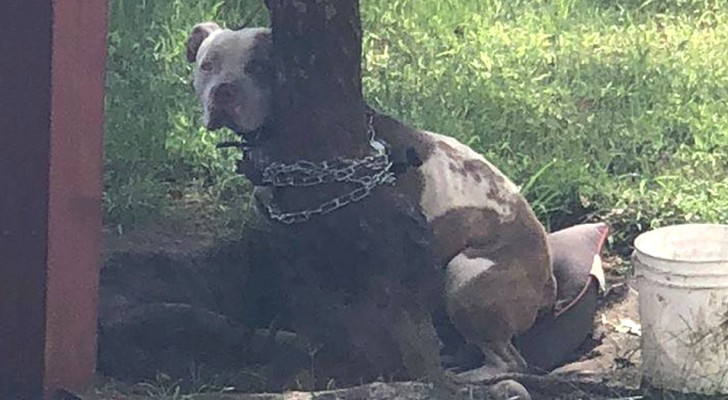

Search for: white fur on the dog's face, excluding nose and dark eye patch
xmin=194 ymin=28 xmax=271 ymax=132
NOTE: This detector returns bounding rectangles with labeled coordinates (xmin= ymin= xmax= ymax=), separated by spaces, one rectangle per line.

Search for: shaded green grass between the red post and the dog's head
xmin=104 ymin=0 xmax=268 ymax=225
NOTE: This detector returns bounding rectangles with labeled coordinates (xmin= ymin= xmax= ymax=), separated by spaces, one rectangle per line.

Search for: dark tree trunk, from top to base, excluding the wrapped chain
xmin=253 ymin=0 xmax=445 ymax=384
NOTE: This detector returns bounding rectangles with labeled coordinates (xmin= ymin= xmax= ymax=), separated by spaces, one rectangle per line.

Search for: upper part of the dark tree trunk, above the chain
xmin=266 ymin=0 xmax=368 ymax=162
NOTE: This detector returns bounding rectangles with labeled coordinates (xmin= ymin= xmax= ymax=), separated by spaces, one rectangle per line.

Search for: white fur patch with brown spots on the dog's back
xmin=420 ymin=132 xmax=518 ymax=221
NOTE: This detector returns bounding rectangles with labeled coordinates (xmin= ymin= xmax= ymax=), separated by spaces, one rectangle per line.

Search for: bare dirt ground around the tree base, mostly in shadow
xmin=89 ymin=206 xmax=724 ymax=400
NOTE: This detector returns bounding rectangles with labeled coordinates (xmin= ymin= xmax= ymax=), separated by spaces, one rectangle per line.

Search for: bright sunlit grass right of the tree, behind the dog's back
xmin=362 ymin=0 xmax=728 ymax=238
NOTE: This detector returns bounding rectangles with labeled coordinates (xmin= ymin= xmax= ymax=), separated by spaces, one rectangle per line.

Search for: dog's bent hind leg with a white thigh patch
xmin=445 ymin=248 xmax=555 ymax=381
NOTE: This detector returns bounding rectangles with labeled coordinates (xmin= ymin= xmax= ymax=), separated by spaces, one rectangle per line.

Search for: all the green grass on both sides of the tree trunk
xmin=106 ymin=0 xmax=728 ymax=247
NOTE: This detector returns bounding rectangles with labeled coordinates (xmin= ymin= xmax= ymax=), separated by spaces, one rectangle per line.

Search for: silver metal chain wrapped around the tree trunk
xmin=263 ymin=109 xmax=395 ymax=224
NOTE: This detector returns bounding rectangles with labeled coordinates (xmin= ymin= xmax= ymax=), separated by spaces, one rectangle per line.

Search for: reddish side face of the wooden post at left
xmin=45 ymin=0 xmax=107 ymax=390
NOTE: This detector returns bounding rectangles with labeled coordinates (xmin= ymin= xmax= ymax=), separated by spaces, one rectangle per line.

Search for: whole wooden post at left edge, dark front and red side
xmin=0 ymin=0 xmax=107 ymax=399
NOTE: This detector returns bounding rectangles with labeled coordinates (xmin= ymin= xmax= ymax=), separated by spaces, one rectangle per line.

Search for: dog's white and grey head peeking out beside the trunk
xmin=187 ymin=22 xmax=274 ymax=134
